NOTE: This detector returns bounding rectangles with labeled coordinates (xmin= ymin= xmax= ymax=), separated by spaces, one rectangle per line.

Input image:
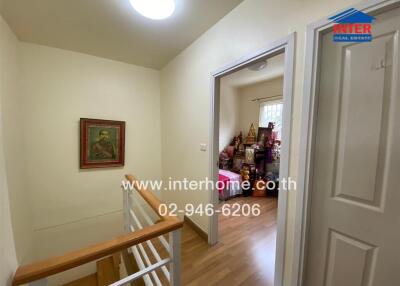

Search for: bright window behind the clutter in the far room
xmin=259 ymin=100 xmax=283 ymax=140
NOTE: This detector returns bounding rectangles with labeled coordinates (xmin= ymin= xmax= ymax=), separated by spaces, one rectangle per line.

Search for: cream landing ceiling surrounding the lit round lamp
xmin=0 ymin=0 xmax=243 ymax=69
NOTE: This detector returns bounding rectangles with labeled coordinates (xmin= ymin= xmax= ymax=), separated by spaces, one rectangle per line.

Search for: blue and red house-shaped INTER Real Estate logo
xmin=329 ymin=8 xmax=375 ymax=42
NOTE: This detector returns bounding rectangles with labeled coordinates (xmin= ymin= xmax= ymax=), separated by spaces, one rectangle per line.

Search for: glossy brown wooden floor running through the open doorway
xmin=182 ymin=197 xmax=278 ymax=286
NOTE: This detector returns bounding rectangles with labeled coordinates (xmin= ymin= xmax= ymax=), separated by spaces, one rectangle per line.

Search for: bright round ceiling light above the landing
xmin=129 ymin=0 xmax=175 ymax=20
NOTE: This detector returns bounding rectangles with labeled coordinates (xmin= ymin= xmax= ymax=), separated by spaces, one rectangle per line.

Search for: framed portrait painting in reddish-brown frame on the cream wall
xmin=80 ymin=118 xmax=125 ymax=169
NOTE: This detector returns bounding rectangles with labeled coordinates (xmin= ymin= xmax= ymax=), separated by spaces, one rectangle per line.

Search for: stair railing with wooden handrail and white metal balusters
xmin=12 ymin=175 xmax=183 ymax=286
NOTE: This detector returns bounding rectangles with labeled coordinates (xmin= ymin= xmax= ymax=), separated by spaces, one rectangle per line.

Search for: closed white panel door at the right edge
xmin=305 ymin=6 xmax=400 ymax=286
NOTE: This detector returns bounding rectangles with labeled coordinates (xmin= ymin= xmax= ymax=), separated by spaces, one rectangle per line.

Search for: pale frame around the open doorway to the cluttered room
xmin=208 ymin=33 xmax=296 ymax=286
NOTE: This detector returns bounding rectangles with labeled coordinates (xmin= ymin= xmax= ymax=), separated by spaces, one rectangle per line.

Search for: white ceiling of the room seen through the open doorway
xmin=222 ymin=54 xmax=285 ymax=88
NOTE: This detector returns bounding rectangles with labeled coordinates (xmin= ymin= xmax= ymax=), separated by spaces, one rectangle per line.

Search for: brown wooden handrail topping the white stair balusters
xmin=12 ymin=175 xmax=183 ymax=286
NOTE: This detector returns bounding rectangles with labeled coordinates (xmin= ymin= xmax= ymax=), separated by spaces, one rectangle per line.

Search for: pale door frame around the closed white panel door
xmin=291 ymin=0 xmax=400 ymax=286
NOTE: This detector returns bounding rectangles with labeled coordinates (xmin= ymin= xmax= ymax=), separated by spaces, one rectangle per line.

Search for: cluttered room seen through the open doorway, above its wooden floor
xmin=218 ymin=56 xmax=283 ymax=202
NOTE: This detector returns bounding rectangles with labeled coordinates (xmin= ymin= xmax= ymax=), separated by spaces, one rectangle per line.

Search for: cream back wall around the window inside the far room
xmin=238 ymin=77 xmax=283 ymax=136
